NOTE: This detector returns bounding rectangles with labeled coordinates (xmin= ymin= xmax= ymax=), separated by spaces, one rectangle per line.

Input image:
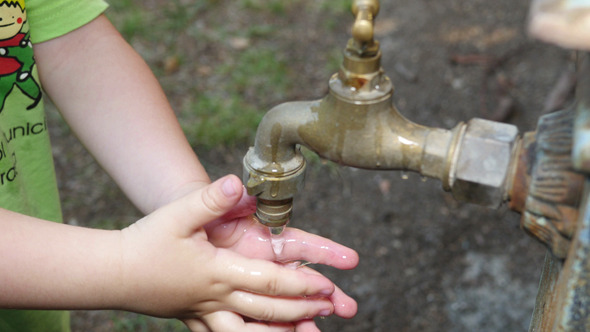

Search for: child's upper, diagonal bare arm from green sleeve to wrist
xmin=34 ymin=16 xmax=210 ymax=213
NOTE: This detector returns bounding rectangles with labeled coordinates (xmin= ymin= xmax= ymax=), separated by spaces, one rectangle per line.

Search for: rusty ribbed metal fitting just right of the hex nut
xmin=517 ymin=110 xmax=584 ymax=258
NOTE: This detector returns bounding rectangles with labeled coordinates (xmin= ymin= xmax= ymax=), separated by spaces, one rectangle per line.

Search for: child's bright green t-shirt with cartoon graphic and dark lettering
xmin=0 ymin=0 xmax=107 ymax=332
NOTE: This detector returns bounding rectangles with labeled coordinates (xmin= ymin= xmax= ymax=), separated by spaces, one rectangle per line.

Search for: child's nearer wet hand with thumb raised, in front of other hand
xmin=121 ymin=176 xmax=357 ymax=331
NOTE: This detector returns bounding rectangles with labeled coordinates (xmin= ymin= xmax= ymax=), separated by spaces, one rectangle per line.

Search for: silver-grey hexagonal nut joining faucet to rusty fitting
xmin=451 ymin=118 xmax=518 ymax=207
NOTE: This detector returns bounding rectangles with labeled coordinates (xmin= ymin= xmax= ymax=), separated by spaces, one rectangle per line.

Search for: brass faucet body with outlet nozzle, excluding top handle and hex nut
xmin=244 ymin=47 xmax=464 ymax=228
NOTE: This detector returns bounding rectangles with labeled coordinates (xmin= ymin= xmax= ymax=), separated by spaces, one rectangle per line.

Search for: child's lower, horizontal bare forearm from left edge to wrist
xmin=0 ymin=209 xmax=124 ymax=309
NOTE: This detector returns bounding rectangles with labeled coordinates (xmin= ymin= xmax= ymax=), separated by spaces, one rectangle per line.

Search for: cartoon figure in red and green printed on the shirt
xmin=0 ymin=0 xmax=42 ymax=113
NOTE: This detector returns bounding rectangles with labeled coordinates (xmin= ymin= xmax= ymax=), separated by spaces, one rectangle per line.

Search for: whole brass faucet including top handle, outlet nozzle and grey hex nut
xmin=244 ymin=0 xmax=519 ymax=233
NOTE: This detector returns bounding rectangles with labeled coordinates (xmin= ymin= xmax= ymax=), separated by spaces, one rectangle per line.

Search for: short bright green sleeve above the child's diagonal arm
xmin=26 ymin=0 xmax=108 ymax=43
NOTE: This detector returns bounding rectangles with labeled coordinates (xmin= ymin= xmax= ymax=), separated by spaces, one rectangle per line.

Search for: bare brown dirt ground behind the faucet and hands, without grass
xmin=54 ymin=0 xmax=571 ymax=332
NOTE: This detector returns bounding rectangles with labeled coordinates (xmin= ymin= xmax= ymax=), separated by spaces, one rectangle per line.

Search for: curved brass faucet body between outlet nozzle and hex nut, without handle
xmin=245 ymin=69 xmax=462 ymax=176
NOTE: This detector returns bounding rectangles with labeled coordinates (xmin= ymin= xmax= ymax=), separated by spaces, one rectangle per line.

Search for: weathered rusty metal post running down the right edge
xmin=527 ymin=54 xmax=590 ymax=332
